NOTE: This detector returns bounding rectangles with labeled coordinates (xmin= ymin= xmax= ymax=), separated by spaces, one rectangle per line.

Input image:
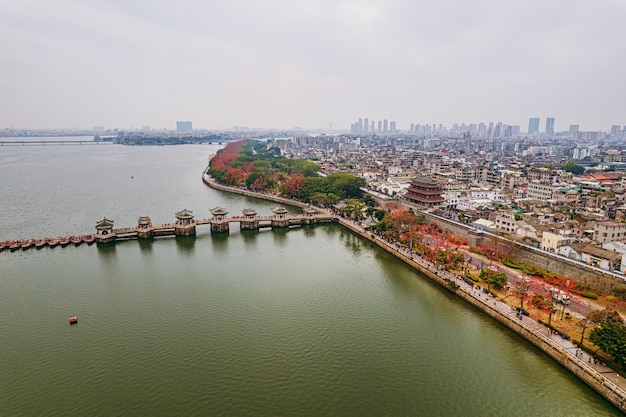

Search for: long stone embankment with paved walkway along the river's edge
xmin=202 ymin=174 xmax=626 ymax=412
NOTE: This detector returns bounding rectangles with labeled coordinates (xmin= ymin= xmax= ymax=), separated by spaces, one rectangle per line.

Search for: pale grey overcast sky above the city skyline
xmin=0 ymin=0 xmax=626 ymax=131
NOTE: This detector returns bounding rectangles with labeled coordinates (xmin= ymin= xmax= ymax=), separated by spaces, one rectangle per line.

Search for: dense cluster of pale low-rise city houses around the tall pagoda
xmin=277 ymin=137 xmax=626 ymax=273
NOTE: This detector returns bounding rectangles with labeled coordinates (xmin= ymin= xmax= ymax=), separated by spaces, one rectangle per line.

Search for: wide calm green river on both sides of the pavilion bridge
xmin=0 ymin=139 xmax=622 ymax=416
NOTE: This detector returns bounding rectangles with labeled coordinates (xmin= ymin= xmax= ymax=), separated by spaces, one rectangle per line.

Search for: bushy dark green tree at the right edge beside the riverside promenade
xmin=587 ymin=309 xmax=626 ymax=364
